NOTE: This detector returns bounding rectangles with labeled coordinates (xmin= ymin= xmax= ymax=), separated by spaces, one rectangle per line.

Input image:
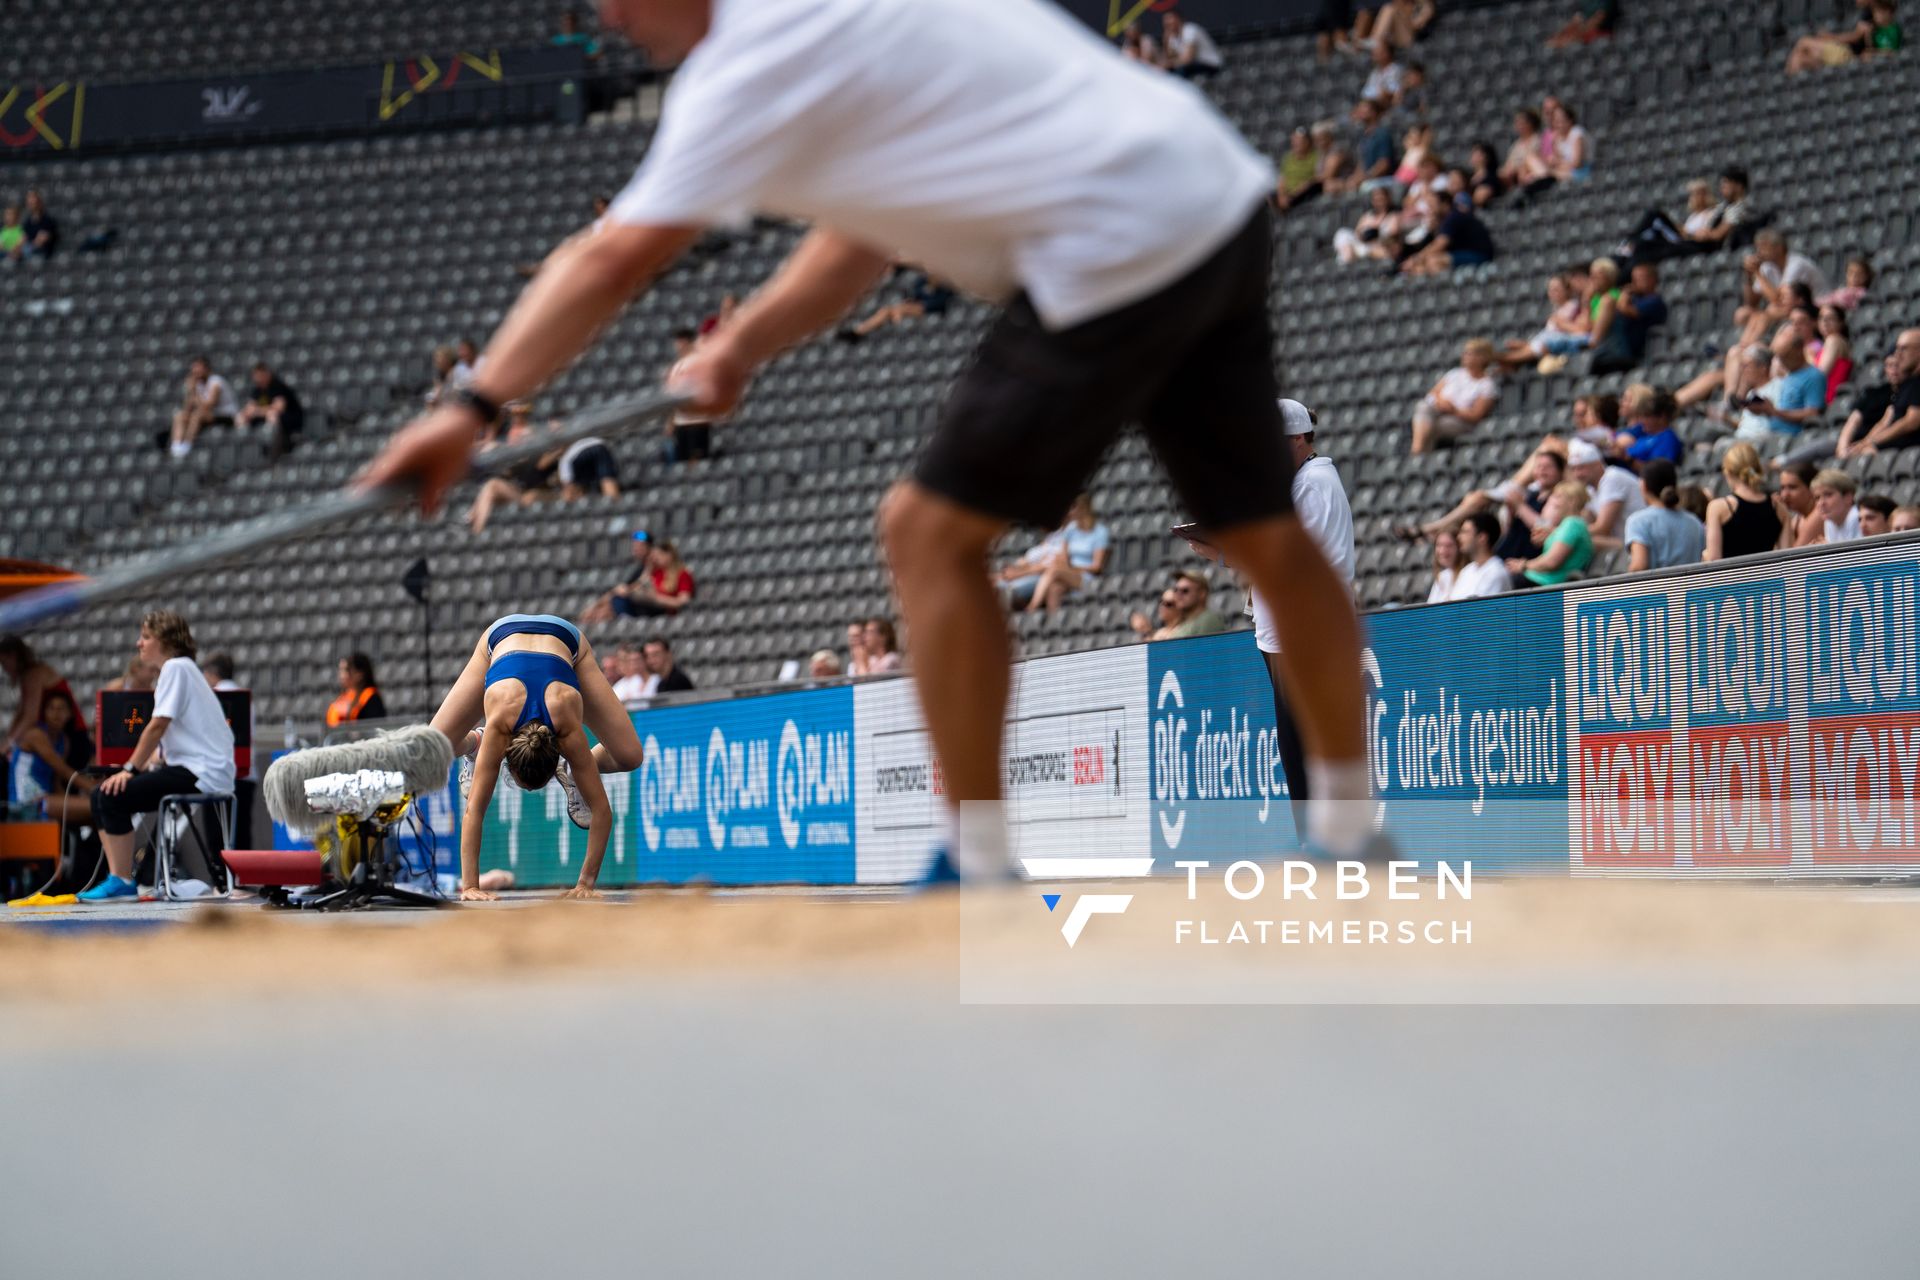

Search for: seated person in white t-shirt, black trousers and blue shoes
xmin=81 ymin=612 xmax=234 ymax=902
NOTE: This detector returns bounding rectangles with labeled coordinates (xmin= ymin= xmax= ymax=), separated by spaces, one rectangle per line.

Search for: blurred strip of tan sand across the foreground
xmin=11 ymin=879 xmax=1920 ymax=1004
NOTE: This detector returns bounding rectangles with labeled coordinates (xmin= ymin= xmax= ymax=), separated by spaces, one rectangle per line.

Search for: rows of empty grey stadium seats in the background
xmin=0 ymin=0 xmax=1920 ymax=723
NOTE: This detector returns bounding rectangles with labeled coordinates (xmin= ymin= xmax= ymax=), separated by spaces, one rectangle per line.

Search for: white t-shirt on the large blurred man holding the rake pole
xmin=609 ymin=0 xmax=1277 ymax=328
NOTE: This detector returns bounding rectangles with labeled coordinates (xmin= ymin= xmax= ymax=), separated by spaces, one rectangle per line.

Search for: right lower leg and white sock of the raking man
xmin=1213 ymin=516 xmax=1371 ymax=856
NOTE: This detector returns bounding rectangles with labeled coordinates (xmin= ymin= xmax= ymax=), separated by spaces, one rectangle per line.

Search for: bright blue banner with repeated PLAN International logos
xmin=632 ymin=685 xmax=856 ymax=885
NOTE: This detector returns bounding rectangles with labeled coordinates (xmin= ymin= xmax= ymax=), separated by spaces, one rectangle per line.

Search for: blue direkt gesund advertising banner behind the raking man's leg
xmin=1148 ymin=595 xmax=1569 ymax=871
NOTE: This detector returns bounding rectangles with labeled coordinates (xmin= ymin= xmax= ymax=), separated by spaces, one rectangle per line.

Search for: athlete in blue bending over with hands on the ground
xmin=434 ymin=614 xmax=641 ymax=900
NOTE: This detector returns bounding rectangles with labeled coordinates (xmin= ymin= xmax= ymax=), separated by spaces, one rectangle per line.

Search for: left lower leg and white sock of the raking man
xmin=879 ymin=480 xmax=1012 ymax=875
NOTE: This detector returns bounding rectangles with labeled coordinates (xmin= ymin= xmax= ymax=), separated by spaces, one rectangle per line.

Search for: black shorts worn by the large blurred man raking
xmin=914 ymin=203 xmax=1294 ymax=530
